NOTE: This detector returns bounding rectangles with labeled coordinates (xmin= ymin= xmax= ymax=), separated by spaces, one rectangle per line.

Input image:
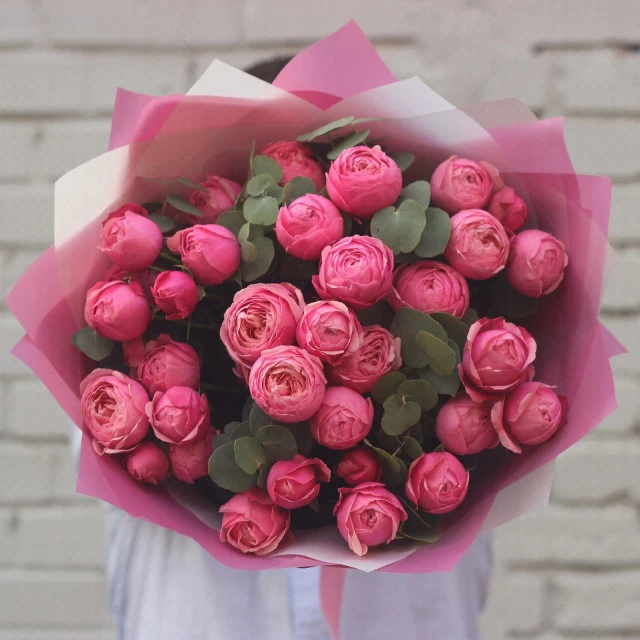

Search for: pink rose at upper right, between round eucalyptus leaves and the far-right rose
xmin=444 ymin=209 xmax=509 ymax=280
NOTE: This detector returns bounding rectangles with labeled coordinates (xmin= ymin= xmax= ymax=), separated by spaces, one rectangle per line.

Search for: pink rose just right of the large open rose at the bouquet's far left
xmin=146 ymin=387 xmax=211 ymax=445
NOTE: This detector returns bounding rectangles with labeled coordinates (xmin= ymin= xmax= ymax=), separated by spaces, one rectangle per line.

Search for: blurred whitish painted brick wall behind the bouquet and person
xmin=0 ymin=0 xmax=640 ymax=640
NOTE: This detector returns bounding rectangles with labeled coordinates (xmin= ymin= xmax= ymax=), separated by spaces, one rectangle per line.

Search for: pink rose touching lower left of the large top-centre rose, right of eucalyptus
xmin=276 ymin=193 xmax=344 ymax=260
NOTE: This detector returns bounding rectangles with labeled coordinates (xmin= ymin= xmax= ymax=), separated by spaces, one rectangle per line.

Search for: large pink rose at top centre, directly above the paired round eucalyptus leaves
xmin=327 ymin=145 xmax=402 ymax=220
